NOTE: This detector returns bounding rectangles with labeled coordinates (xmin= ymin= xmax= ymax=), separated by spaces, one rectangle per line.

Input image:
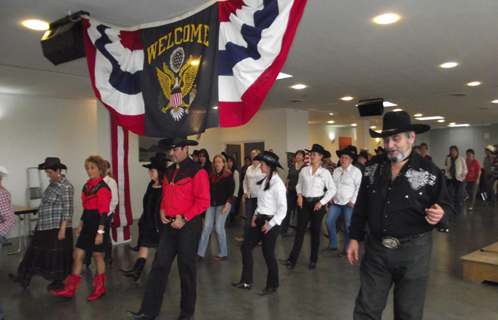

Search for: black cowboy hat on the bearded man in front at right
xmin=370 ymin=111 xmax=431 ymax=138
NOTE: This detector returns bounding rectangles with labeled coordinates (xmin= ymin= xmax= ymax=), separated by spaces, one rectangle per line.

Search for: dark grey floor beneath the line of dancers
xmin=0 ymin=202 xmax=498 ymax=320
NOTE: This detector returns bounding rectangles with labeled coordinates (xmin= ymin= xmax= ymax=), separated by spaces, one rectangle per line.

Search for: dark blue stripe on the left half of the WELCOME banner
xmin=95 ymin=25 xmax=142 ymax=94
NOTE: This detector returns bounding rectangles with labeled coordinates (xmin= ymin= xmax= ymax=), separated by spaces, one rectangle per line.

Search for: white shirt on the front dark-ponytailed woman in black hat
xmin=254 ymin=173 xmax=287 ymax=228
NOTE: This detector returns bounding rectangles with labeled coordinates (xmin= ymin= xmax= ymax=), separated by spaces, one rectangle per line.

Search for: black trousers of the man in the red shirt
xmin=140 ymin=216 xmax=202 ymax=318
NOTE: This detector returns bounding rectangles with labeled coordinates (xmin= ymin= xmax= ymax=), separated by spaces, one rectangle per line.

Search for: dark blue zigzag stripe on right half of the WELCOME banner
xmin=218 ymin=0 xmax=279 ymax=76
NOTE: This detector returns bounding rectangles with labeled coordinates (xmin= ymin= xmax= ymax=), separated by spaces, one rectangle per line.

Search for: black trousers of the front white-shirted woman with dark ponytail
xmin=240 ymin=217 xmax=280 ymax=288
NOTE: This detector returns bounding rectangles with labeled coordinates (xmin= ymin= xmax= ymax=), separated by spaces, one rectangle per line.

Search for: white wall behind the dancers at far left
xmin=0 ymin=94 xmax=98 ymax=237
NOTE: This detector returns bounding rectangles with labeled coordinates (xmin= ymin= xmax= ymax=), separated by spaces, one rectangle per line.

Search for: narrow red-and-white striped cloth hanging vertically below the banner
xmin=111 ymin=116 xmax=133 ymax=243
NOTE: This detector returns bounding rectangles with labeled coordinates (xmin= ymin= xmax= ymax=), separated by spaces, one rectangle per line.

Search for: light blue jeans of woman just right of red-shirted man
xmin=197 ymin=205 xmax=231 ymax=257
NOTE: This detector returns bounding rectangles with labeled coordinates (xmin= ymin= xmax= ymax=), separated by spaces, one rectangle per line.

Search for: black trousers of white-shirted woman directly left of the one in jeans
xmin=289 ymin=198 xmax=326 ymax=265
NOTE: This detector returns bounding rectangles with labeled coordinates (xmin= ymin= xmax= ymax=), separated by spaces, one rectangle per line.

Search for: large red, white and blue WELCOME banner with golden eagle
xmin=83 ymin=0 xmax=306 ymax=138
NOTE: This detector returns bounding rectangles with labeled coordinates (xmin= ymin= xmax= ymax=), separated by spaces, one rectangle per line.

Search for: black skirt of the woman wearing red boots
xmin=76 ymin=210 xmax=110 ymax=252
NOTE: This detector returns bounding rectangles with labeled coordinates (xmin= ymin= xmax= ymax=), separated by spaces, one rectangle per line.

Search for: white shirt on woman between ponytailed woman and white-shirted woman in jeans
xmin=296 ymin=166 xmax=336 ymax=205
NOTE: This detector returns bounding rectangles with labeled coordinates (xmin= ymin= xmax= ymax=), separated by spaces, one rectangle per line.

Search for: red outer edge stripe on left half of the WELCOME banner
xmin=82 ymin=19 xmax=145 ymax=136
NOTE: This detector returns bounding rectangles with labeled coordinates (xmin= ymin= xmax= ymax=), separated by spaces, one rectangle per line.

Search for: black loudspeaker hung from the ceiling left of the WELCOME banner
xmin=41 ymin=11 xmax=86 ymax=65
